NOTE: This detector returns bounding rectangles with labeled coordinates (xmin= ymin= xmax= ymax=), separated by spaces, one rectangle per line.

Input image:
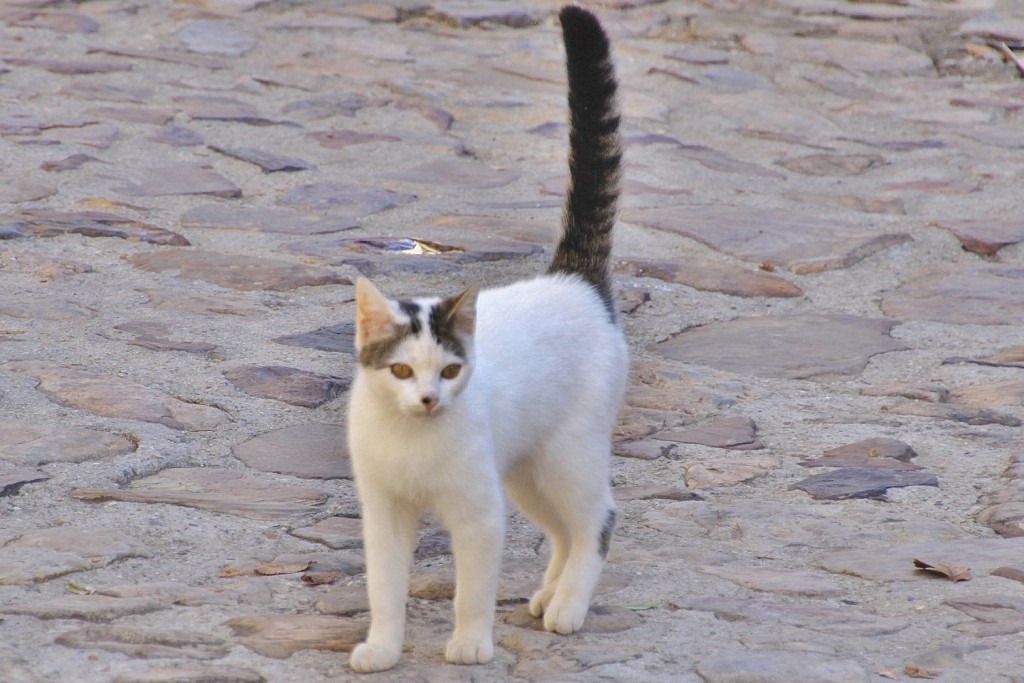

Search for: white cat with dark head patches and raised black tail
xmin=348 ymin=6 xmax=629 ymax=672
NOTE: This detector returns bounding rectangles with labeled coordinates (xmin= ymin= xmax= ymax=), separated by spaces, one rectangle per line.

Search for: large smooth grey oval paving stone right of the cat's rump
xmin=649 ymin=315 xmax=906 ymax=382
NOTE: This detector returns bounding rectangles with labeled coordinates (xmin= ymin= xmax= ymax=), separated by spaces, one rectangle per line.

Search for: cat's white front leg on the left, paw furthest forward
xmin=348 ymin=490 xmax=419 ymax=674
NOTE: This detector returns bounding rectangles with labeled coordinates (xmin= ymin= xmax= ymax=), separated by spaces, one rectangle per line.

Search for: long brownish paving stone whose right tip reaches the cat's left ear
xmin=128 ymin=250 xmax=352 ymax=291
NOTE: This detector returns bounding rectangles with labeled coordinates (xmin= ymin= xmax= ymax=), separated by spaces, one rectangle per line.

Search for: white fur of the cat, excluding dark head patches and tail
xmin=348 ymin=274 xmax=628 ymax=672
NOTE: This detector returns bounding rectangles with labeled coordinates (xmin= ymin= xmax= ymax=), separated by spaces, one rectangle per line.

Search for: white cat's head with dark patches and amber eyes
xmin=355 ymin=278 xmax=477 ymax=417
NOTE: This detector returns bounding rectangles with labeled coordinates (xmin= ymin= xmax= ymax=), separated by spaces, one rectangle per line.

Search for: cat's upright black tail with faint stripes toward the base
xmin=548 ymin=5 xmax=623 ymax=319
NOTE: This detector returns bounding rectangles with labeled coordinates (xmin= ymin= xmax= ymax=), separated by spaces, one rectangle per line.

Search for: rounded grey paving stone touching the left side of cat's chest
xmin=231 ymin=423 xmax=352 ymax=479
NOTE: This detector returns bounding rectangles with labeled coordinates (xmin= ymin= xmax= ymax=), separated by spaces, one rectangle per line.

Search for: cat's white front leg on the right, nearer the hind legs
xmin=440 ymin=482 xmax=505 ymax=665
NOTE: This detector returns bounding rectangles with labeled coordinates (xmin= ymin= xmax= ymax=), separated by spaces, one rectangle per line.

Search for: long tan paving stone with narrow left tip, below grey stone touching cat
xmin=72 ymin=467 xmax=327 ymax=519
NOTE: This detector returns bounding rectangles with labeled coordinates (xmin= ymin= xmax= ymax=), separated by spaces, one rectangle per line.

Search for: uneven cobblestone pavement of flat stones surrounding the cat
xmin=0 ymin=0 xmax=1024 ymax=683
